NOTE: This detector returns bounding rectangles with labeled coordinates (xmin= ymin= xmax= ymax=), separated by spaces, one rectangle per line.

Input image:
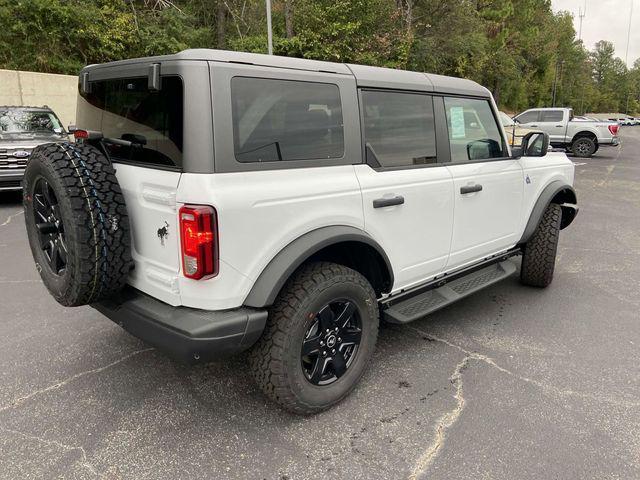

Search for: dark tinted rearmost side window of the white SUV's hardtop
xmin=231 ymin=77 xmax=344 ymax=162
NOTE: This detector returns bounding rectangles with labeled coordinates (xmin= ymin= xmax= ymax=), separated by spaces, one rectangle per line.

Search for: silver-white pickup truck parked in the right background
xmin=514 ymin=108 xmax=620 ymax=158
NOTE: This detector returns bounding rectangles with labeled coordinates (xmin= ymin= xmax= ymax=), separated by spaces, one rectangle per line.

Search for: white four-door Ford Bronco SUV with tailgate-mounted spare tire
xmin=24 ymin=50 xmax=577 ymax=414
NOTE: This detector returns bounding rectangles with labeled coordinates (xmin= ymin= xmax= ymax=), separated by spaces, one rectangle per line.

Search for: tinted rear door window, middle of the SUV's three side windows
xmin=362 ymin=90 xmax=436 ymax=167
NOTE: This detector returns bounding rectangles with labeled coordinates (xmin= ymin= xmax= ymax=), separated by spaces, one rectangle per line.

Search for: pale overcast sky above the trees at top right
xmin=551 ymin=0 xmax=640 ymax=66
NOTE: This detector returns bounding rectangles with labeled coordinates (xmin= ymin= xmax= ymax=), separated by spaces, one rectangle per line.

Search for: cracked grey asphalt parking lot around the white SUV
xmin=0 ymin=127 xmax=640 ymax=480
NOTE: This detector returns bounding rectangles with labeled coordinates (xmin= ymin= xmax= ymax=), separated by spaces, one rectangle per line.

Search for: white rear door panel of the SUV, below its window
xmin=355 ymin=165 xmax=453 ymax=291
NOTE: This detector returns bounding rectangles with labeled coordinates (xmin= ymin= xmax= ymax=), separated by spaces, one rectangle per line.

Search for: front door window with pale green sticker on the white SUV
xmin=444 ymin=97 xmax=506 ymax=162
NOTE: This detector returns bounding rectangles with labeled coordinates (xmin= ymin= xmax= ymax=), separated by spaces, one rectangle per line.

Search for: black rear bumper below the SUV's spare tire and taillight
xmin=91 ymin=287 xmax=267 ymax=363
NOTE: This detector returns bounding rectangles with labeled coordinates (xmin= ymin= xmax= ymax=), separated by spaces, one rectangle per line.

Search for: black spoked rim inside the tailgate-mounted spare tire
xmin=33 ymin=177 xmax=68 ymax=275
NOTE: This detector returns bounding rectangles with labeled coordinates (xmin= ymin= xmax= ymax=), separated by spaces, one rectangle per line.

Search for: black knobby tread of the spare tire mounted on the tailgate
xmin=23 ymin=142 xmax=133 ymax=306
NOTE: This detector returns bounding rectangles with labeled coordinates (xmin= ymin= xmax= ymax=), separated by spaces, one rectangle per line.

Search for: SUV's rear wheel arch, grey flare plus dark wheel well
xmin=244 ymin=225 xmax=393 ymax=308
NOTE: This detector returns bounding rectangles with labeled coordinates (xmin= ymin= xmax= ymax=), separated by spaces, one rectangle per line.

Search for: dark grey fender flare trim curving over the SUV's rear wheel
xmin=244 ymin=225 xmax=393 ymax=308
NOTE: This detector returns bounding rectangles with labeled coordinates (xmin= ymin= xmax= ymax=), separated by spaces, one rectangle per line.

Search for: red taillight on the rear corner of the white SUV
xmin=179 ymin=205 xmax=219 ymax=280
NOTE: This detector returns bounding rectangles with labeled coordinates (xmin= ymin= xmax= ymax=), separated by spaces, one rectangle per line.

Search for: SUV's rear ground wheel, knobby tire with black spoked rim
xmin=249 ymin=262 xmax=379 ymax=415
